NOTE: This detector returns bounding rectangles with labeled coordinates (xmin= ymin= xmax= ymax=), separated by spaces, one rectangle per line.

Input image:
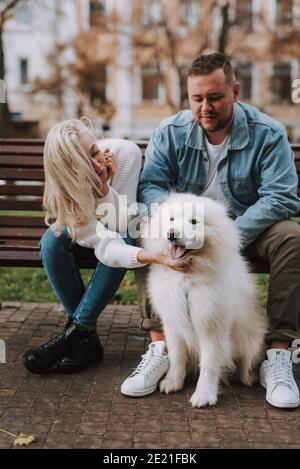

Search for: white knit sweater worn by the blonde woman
xmin=76 ymin=139 xmax=144 ymax=269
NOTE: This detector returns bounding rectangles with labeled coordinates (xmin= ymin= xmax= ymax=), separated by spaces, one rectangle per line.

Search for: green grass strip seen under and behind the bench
xmin=0 ymin=267 xmax=268 ymax=306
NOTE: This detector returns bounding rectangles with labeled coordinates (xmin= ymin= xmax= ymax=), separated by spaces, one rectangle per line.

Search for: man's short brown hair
xmin=188 ymin=52 xmax=236 ymax=85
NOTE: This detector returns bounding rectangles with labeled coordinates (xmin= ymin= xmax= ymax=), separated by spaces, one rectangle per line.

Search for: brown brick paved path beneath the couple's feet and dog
xmin=0 ymin=303 xmax=300 ymax=448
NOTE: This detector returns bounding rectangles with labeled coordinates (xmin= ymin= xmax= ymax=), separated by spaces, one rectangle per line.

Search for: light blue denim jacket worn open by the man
xmin=138 ymin=102 xmax=300 ymax=246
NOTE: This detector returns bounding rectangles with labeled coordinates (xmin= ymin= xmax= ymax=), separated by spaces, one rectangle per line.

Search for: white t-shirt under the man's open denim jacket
xmin=201 ymin=135 xmax=229 ymax=205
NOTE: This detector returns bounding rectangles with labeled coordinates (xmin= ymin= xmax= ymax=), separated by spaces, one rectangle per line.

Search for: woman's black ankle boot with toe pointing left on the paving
xmin=23 ymin=321 xmax=103 ymax=373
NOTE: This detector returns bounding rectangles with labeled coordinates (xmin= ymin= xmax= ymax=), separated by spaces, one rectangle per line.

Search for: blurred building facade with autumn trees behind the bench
xmin=5 ymin=0 xmax=300 ymax=142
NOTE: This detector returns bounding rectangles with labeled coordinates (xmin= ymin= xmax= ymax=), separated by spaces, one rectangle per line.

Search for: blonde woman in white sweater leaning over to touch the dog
xmin=23 ymin=119 xmax=190 ymax=373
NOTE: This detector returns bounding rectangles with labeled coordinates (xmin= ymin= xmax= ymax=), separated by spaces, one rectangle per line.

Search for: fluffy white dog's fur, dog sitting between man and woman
xmin=142 ymin=194 xmax=267 ymax=407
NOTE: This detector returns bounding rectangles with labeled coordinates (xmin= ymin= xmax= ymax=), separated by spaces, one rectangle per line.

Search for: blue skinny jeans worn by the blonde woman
xmin=40 ymin=228 xmax=133 ymax=328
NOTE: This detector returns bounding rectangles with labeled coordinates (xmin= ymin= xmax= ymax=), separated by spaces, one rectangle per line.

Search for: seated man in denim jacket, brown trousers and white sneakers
xmin=121 ymin=53 xmax=300 ymax=407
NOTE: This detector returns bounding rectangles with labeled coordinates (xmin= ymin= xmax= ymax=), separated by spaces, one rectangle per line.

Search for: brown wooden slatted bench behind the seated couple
xmin=0 ymin=139 xmax=300 ymax=272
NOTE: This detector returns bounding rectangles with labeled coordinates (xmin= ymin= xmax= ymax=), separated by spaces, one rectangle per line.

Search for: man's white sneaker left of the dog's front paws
xmin=121 ymin=340 xmax=169 ymax=397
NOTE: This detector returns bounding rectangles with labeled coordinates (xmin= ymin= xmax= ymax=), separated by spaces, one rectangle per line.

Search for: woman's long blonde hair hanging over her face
xmin=43 ymin=118 xmax=102 ymax=240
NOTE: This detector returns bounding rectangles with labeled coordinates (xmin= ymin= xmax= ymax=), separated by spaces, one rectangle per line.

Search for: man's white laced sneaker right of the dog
xmin=259 ymin=349 xmax=299 ymax=408
